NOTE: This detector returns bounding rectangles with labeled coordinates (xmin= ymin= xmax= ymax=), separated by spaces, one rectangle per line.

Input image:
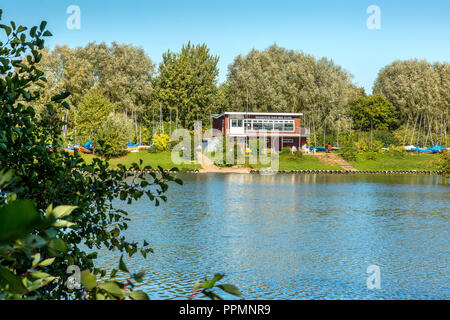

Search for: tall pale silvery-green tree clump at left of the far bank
xmin=32 ymin=42 xmax=155 ymax=144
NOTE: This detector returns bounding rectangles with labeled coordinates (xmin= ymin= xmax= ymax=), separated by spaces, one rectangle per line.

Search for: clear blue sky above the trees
xmin=0 ymin=0 xmax=450 ymax=93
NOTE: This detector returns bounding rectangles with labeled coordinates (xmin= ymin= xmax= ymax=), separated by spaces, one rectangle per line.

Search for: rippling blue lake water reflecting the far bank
xmin=99 ymin=174 xmax=450 ymax=299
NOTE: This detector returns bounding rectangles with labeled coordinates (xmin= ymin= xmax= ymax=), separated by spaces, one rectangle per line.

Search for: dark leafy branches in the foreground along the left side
xmin=0 ymin=10 xmax=241 ymax=299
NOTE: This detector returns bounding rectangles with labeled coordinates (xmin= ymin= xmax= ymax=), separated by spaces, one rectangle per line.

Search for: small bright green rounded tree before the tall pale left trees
xmin=75 ymin=89 xmax=114 ymax=140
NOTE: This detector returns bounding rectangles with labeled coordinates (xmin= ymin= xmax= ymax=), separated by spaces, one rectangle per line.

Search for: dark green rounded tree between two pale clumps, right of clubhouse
xmin=351 ymin=95 xmax=398 ymax=131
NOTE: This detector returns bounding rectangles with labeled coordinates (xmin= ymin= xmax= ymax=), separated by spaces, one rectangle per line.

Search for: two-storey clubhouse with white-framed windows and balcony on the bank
xmin=211 ymin=112 xmax=310 ymax=150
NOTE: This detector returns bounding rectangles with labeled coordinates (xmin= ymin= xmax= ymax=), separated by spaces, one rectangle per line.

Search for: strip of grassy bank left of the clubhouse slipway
xmin=81 ymin=151 xmax=201 ymax=170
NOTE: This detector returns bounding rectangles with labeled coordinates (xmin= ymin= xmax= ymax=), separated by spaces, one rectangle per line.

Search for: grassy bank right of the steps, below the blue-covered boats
xmin=349 ymin=152 xmax=439 ymax=171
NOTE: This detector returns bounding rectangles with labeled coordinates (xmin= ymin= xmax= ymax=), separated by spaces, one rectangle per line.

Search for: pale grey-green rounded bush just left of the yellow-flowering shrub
xmin=94 ymin=112 xmax=133 ymax=158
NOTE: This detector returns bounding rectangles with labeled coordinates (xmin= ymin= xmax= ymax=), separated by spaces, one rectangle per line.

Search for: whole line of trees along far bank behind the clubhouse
xmin=36 ymin=42 xmax=450 ymax=149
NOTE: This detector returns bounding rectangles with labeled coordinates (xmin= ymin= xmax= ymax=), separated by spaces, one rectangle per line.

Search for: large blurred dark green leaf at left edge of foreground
xmin=0 ymin=200 xmax=44 ymax=244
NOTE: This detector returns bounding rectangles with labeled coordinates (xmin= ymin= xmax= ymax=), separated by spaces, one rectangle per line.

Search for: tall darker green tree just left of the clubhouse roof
xmin=153 ymin=42 xmax=219 ymax=128
